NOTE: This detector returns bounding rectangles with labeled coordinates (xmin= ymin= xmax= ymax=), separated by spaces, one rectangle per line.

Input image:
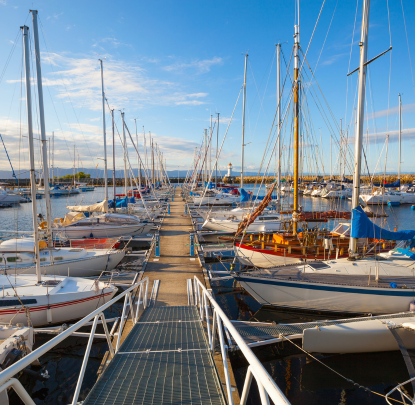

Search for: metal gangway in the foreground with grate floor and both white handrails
xmin=0 ymin=276 xmax=289 ymax=405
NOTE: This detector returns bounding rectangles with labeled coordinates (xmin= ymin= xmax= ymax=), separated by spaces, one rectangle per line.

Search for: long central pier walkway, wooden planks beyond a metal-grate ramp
xmin=84 ymin=188 xmax=254 ymax=405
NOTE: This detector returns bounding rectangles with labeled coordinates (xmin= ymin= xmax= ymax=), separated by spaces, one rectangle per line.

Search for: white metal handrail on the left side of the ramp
xmin=0 ymin=277 xmax=149 ymax=405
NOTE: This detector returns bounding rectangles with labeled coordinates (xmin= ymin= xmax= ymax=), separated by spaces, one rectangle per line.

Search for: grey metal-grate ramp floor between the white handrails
xmin=84 ymin=305 xmax=226 ymax=405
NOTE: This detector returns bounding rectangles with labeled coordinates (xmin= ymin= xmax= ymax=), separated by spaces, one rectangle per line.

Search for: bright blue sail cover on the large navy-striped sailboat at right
xmin=351 ymin=207 xmax=415 ymax=240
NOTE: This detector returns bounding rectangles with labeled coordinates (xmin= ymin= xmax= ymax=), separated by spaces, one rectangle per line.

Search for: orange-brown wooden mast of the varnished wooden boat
xmin=293 ymin=0 xmax=300 ymax=235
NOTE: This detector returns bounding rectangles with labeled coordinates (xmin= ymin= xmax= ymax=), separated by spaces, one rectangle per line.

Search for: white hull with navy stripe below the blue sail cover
xmin=235 ymin=275 xmax=413 ymax=314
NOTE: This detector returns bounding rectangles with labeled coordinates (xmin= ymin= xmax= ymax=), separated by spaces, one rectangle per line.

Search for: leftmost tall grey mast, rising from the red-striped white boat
xmin=21 ymin=26 xmax=42 ymax=284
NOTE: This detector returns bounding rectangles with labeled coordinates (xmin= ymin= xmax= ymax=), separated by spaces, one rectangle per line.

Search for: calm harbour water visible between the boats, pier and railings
xmin=5 ymin=185 xmax=415 ymax=405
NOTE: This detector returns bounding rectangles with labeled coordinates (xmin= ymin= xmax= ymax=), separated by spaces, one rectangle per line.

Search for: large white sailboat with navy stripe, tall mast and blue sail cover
xmin=234 ymin=0 xmax=415 ymax=314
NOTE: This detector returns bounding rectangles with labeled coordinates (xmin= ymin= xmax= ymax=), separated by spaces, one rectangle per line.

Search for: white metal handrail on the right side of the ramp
xmin=194 ymin=276 xmax=290 ymax=405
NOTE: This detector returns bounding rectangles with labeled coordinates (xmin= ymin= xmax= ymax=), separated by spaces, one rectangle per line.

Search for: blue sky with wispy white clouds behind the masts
xmin=0 ymin=0 xmax=415 ymax=174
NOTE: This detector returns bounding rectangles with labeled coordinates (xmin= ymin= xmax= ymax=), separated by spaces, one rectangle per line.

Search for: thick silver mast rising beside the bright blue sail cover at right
xmin=349 ymin=0 xmax=370 ymax=254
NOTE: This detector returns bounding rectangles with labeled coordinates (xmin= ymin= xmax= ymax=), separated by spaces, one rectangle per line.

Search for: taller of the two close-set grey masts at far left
xmin=31 ymin=10 xmax=53 ymax=247
